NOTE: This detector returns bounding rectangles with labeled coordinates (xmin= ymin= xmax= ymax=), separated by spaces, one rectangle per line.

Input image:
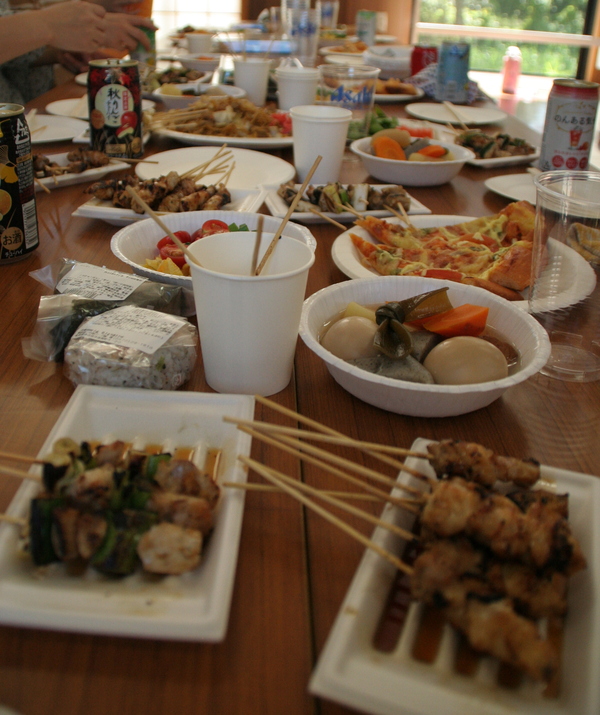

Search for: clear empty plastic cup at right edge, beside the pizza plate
xmin=529 ymin=171 xmax=600 ymax=382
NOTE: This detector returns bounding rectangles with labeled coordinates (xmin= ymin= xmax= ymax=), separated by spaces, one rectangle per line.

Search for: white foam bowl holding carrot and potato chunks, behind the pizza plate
xmin=350 ymin=137 xmax=475 ymax=186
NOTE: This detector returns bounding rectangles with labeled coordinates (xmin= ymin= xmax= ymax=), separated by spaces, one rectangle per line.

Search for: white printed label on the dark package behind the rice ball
xmin=56 ymin=263 xmax=147 ymax=300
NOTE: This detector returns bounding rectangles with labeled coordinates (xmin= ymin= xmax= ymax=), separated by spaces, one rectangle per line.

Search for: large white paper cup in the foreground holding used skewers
xmin=188 ymin=231 xmax=315 ymax=396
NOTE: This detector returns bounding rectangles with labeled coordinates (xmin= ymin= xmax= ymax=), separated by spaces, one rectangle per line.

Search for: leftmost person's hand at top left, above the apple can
xmin=39 ymin=0 xmax=106 ymax=52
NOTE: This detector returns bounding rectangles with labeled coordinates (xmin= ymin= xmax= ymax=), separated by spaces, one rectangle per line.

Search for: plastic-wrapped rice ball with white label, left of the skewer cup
xmin=64 ymin=306 xmax=198 ymax=390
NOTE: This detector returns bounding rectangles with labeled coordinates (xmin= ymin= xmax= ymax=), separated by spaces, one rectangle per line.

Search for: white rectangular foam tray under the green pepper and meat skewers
xmin=0 ymin=385 xmax=254 ymax=641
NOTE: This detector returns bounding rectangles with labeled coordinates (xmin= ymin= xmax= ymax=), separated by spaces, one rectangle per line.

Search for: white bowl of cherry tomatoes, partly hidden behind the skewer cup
xmin=110 ymin=211 xmax=317 ymax=290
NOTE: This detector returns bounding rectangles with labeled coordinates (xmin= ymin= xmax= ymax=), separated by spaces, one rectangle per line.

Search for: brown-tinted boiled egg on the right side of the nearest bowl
xmin=423 ymin=336 xmax=508 ymax=385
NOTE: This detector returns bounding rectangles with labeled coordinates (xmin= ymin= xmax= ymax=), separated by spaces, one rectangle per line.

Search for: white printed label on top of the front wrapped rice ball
xmin=75 ymin=305 xmax=185 ymax=355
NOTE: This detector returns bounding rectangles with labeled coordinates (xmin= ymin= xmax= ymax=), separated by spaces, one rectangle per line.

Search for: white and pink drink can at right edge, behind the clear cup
xmin=538 ymin=79 xmax=600 ymax=171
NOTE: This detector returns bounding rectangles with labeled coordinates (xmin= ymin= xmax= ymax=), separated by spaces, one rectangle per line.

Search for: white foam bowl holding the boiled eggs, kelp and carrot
xmin=300 ymin=276 xmax=550 ymax=417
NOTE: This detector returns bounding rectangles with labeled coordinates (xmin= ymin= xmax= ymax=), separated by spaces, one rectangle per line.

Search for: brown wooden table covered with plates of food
xmin=0 ymin=84 xmax=600 ymax=715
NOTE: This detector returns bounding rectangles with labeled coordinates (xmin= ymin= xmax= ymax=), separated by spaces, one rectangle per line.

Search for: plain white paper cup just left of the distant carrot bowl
xmin=290 ymin=104 xmax=352 ymax=184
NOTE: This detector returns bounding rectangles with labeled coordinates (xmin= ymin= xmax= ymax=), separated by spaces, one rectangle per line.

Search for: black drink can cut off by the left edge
xmin=0 ymin=104 xmax=39 ymax=263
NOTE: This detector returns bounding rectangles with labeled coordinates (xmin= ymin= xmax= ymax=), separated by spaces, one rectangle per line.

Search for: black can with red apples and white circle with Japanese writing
xmin=88 ymin=59 xmax=143 ymax=159
